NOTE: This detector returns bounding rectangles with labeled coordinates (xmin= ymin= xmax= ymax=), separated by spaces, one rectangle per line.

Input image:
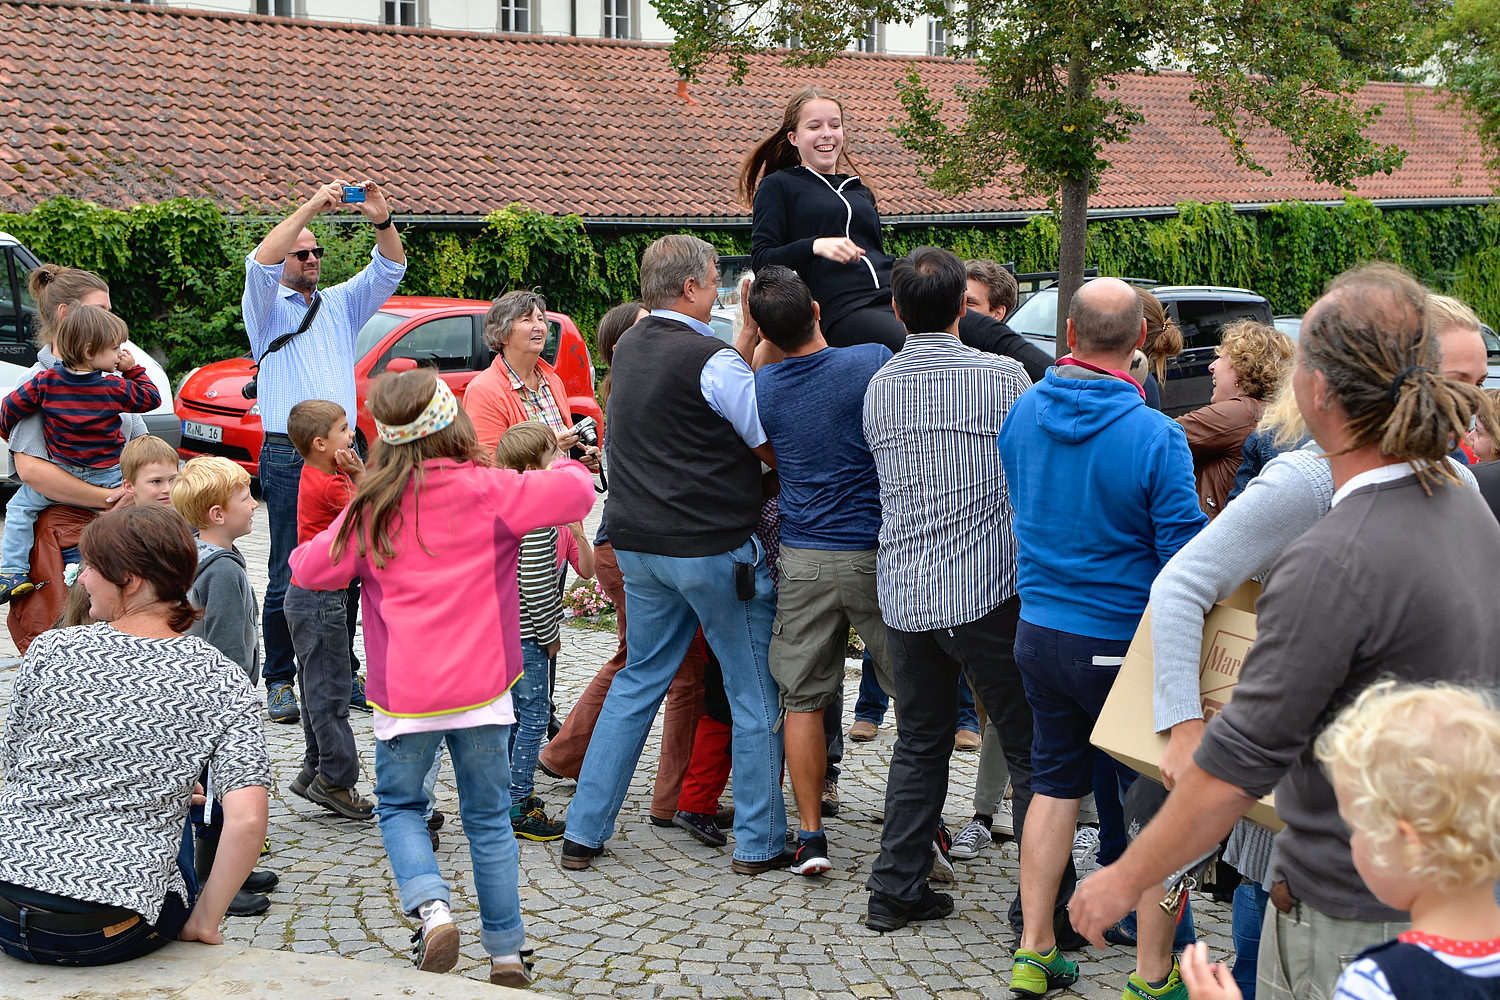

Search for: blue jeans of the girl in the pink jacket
xmin=375 ymin=726 xmax=527 ymax=955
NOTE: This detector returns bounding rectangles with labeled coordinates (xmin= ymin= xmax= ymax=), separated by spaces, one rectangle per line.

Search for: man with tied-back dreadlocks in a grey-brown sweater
xmin=1073 ymin=265 xmax=1500 ymax=1000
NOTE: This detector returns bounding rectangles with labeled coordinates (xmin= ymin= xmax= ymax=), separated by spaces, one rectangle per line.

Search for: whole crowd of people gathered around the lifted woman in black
xmin=0 ymin=88 xmax=1500 ymax=1000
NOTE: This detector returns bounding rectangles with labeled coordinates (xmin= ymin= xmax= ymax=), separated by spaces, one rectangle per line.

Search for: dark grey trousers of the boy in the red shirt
xmin=284 ymin=585 xmax=360 ymax=789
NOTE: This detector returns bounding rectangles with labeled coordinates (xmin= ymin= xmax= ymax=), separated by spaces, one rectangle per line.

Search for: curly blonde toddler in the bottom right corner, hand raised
xmin=1182 ymin=681 xmax=1500 ymax=1000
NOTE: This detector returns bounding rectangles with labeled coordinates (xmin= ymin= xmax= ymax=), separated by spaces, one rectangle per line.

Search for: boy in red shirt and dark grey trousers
xmin=284 ymin=399 xmax=375 ymax=820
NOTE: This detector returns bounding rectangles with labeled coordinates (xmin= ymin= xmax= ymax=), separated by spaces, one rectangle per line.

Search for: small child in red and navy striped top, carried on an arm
xmin=0 ymin=306 xmax=162 ymax=604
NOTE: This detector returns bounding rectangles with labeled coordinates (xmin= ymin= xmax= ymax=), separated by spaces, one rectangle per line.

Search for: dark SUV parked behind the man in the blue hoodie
xmin=1005 ymin=285 xmax=1271 ymax=417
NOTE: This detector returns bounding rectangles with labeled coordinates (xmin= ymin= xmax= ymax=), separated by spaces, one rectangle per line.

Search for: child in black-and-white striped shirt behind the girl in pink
xmin=495 ymin=420 xmax=593 ymax=841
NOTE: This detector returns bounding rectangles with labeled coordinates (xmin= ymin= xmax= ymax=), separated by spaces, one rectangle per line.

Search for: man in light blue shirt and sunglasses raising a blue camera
xmin=240 ymin=180 xmax=407 ymax=723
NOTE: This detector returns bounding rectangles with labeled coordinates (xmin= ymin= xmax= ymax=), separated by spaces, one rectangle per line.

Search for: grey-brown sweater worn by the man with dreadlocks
xmin=1194 ymin=475 xmax=1500 ymax=921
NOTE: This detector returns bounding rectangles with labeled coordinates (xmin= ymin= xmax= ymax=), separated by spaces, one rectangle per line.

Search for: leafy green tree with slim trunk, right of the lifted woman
xmin=657 ymin=0 xmax=1422 ymax=346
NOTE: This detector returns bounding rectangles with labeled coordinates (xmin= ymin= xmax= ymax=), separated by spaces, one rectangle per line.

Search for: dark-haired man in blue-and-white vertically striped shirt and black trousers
xmin=864 ymin=247 xmax=1032 ymax=931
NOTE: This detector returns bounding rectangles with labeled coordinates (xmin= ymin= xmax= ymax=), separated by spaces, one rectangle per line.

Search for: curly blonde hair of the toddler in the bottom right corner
xmin=1316 ymin=681 xmax=1500 ymax=892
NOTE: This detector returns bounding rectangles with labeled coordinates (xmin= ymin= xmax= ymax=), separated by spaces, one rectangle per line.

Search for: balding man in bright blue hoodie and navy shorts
xmin=999 ymin=277 xmax=1206 ymax=1000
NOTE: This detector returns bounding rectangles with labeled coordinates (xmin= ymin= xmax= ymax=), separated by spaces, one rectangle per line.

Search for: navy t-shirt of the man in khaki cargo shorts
xmin=755 ymin=343 xmax=891 ymax=552
